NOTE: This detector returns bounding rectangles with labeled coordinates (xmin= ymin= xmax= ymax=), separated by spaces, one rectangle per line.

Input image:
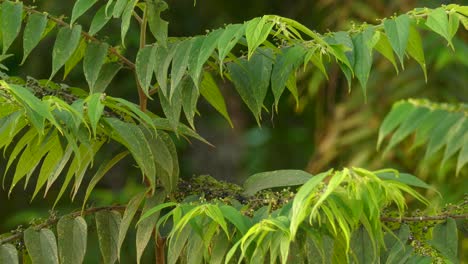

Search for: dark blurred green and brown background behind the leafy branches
xmin=0 ymin=0 xmax=468 ymax=263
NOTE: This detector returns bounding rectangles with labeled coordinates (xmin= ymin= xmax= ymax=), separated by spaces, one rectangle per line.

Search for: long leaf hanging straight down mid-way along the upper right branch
xmin=352 ymin=27 xmax=374 ymax=98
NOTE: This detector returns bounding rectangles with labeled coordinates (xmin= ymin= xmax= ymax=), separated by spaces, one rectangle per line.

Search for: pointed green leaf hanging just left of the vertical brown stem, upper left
xmin=83 ymin=42 xmax=109 ymax=94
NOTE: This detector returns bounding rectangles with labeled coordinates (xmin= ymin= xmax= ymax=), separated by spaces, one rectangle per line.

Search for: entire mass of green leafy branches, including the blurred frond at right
xmin=0 ymin=0 xmax=468 ymax=263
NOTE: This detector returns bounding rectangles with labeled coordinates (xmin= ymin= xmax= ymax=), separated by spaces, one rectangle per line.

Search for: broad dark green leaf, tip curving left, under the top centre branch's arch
xmin=271 ymin=45 xmax=307 ymax=109
